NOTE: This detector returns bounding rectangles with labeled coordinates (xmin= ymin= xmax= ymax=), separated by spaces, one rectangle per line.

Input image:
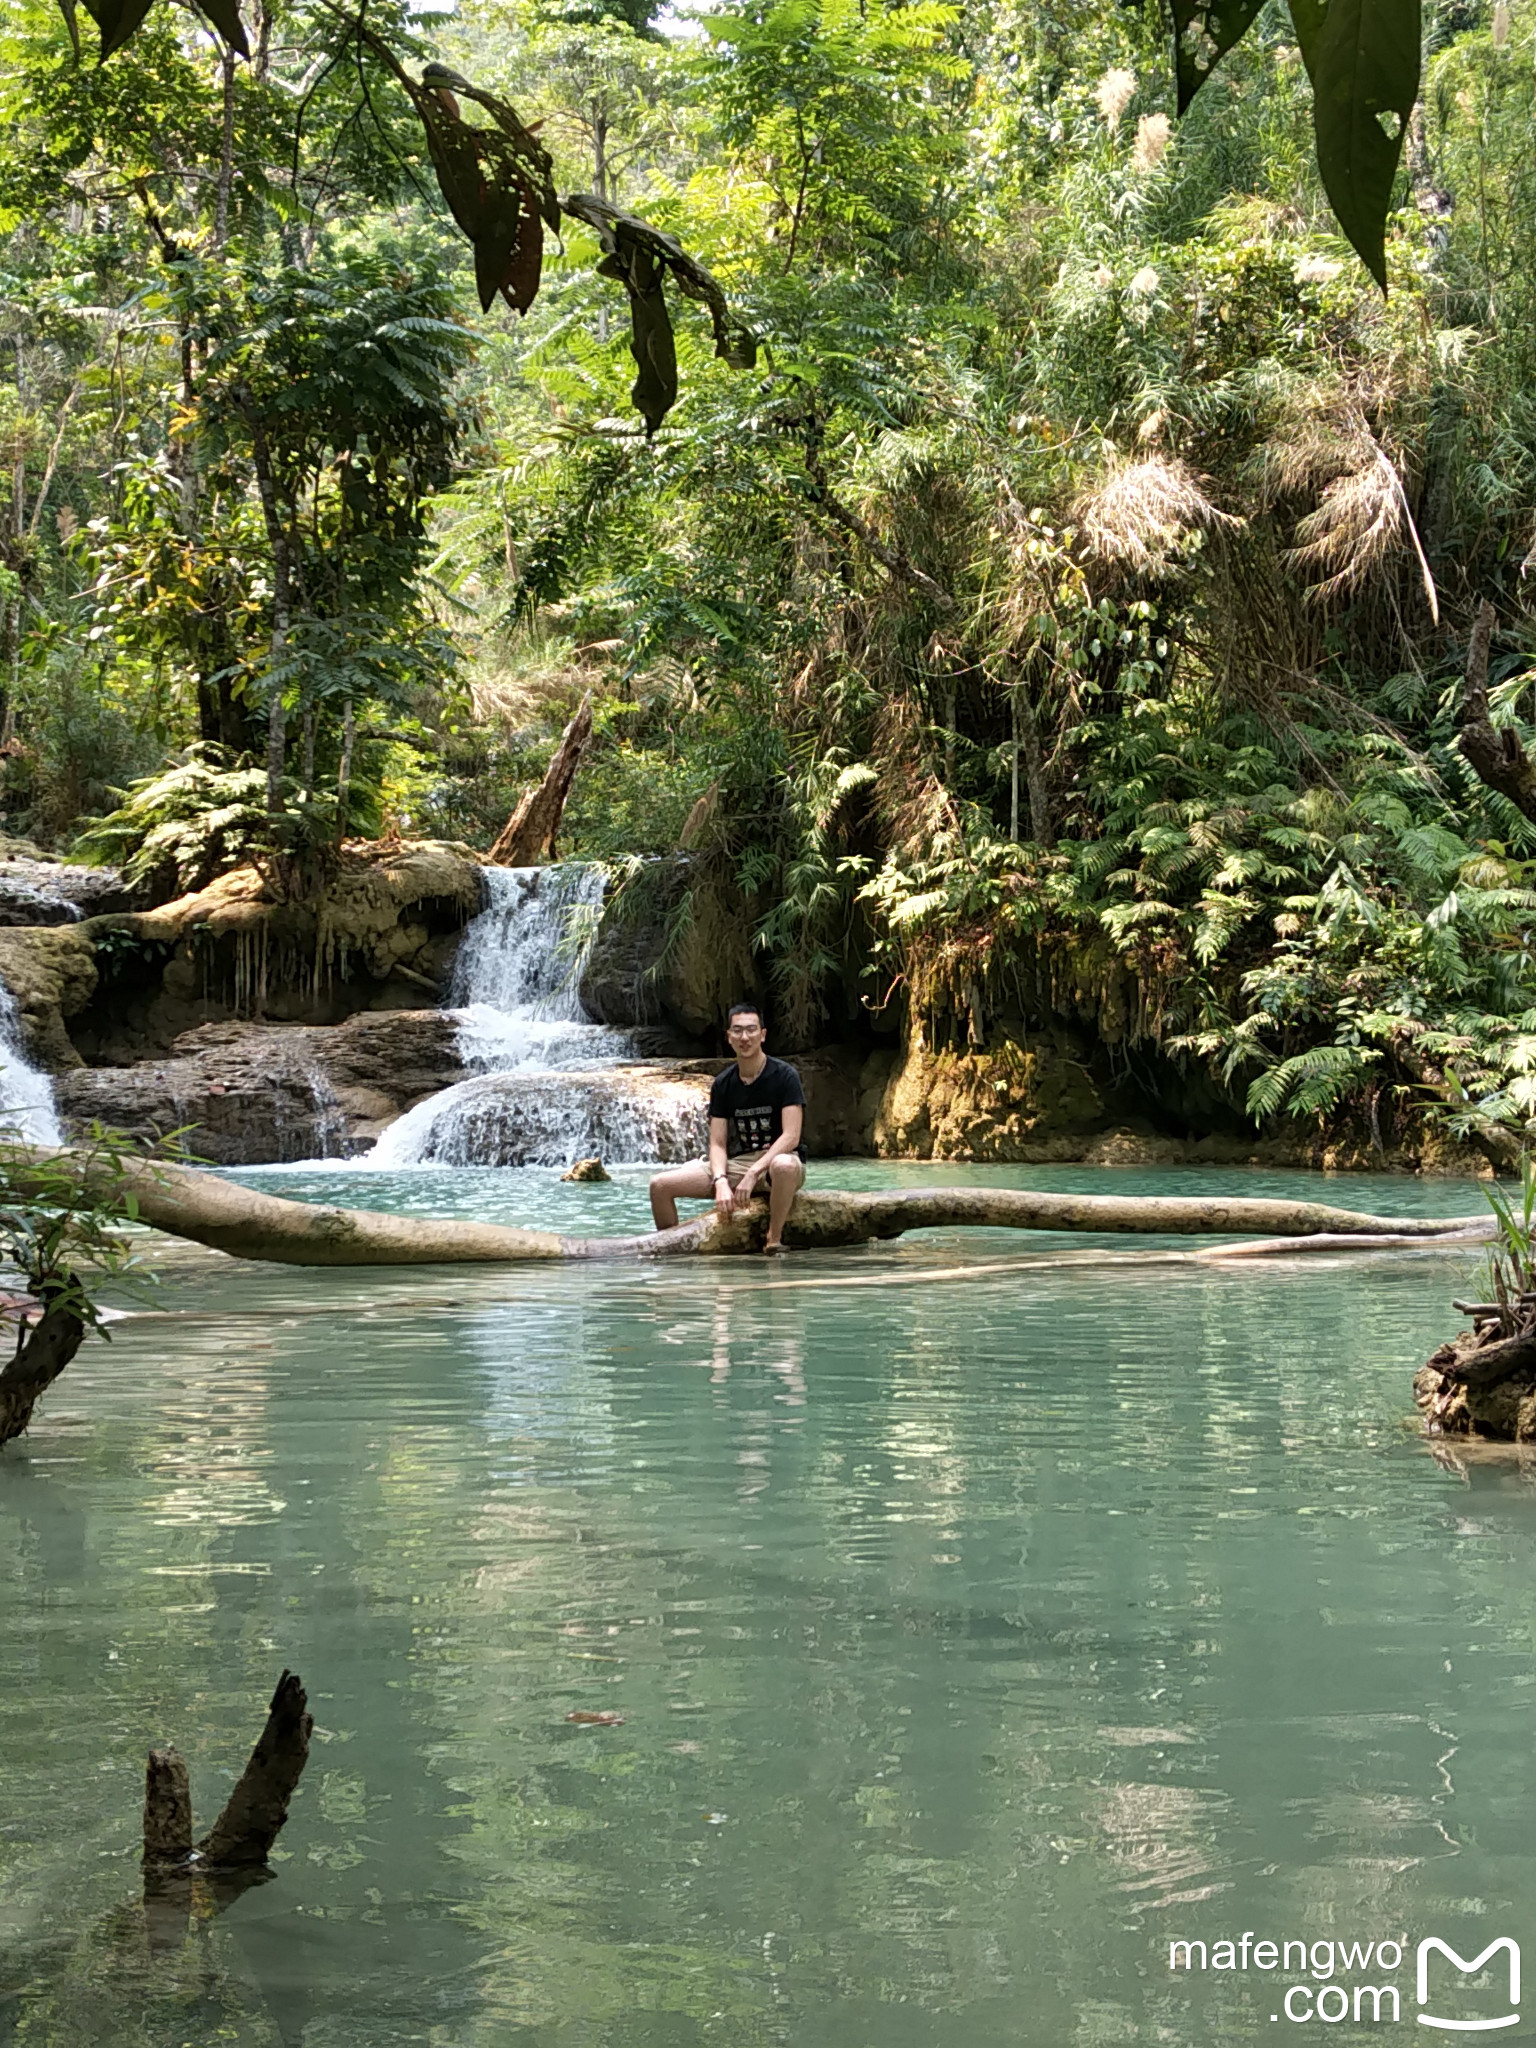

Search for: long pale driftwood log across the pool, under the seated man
xmin=8 ymin=1151 xmax=1489 ymax=1266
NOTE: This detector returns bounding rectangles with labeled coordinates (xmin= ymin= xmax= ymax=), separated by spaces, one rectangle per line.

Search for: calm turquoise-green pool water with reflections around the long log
xmin=0 ymin=1165 xmax=1536 ymax=2048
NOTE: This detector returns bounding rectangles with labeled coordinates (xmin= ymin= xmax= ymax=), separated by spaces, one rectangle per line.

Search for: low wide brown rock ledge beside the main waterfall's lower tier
xmin=55 ymin=1010 xmax=465 ymax=1165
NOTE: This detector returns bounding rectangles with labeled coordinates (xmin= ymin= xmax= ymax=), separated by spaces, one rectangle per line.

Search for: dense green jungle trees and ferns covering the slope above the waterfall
xmin=0 ymin=0 xmax=1536 ymax=1157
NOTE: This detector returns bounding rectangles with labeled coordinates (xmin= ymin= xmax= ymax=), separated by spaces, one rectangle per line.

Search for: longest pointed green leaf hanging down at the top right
xmin=1290 ymin=0 xmax=1421 ymax=291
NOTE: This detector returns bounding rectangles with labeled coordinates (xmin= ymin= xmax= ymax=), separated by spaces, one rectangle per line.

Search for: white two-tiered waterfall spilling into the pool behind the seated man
xmin=369 ymin=862 xmax=707 ymax=1167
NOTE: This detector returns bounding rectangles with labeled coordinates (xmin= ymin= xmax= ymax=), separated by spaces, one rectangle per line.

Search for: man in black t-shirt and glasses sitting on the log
xmin=651 ymin=1004 xmax=805 ymax=1251
